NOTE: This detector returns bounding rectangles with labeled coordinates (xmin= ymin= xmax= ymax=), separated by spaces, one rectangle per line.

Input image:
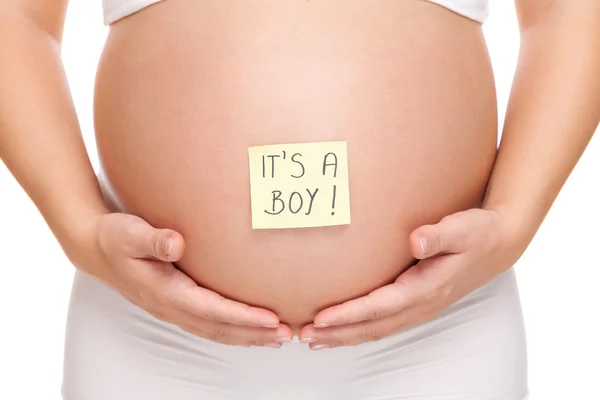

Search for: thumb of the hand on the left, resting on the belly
xmin=123 ymin=218 xmax=185 ymax=262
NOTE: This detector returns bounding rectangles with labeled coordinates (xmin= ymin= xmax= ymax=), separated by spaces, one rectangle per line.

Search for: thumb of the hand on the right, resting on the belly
xmin=409 ymin=213 xmax=469 ymax=259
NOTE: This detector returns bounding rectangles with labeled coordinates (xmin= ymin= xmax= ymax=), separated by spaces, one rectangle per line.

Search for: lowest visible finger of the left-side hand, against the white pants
xmin=177 ymin=314 xmax=294 ymax=348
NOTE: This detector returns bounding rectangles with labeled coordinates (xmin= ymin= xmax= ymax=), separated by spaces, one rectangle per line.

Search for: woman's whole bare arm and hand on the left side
xmin=0 ymin=0 xmax=292 ymax=347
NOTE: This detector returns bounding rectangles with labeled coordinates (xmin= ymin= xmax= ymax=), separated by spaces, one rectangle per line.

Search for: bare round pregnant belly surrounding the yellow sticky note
xmin=95 ymin=0 xmax=497 ymax=327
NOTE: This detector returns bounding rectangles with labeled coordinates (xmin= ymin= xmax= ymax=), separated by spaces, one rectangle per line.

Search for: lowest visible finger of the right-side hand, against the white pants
xmin=300 ymin=306 xmax=432 ymax=350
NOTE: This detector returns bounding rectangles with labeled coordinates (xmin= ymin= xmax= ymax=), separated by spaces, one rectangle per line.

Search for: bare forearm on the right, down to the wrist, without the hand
xmin=484 ymin=2 xmax=600 ymax=246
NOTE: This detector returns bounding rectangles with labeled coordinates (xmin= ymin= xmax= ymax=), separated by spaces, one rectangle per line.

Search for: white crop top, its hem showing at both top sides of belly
xmin=102 ymin=0 xmax=490 ymax=25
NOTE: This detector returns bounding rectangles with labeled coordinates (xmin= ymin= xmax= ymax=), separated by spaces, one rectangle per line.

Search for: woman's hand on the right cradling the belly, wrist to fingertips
xmin=299 ymin=208 xmax=527 ymax=350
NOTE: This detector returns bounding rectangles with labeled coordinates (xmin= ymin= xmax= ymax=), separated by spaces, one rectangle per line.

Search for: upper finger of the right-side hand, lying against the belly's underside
xmin=314 ymin=281 xmax=423 ymax=328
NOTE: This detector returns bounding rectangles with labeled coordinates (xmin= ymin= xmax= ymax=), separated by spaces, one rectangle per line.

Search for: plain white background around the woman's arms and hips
xmin=0 ymin=0 xmax=600 ymax=400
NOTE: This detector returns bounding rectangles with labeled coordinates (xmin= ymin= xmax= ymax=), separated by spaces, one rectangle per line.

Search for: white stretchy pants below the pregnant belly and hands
xmin=63 ymin=269 xmax=527 ymax=400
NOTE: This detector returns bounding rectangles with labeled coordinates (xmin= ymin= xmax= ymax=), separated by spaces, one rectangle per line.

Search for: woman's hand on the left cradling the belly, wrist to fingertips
xmin=65 ymin=213 xmax=293 ymax=347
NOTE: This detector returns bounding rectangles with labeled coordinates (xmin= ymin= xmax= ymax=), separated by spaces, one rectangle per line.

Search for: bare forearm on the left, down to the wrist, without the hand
xmin=0 ymin=15 xmax=106 ymax=250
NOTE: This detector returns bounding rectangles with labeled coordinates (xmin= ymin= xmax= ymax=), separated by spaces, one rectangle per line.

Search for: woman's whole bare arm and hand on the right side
xmin=300 ymin=0 xmax=600 ymax=350
